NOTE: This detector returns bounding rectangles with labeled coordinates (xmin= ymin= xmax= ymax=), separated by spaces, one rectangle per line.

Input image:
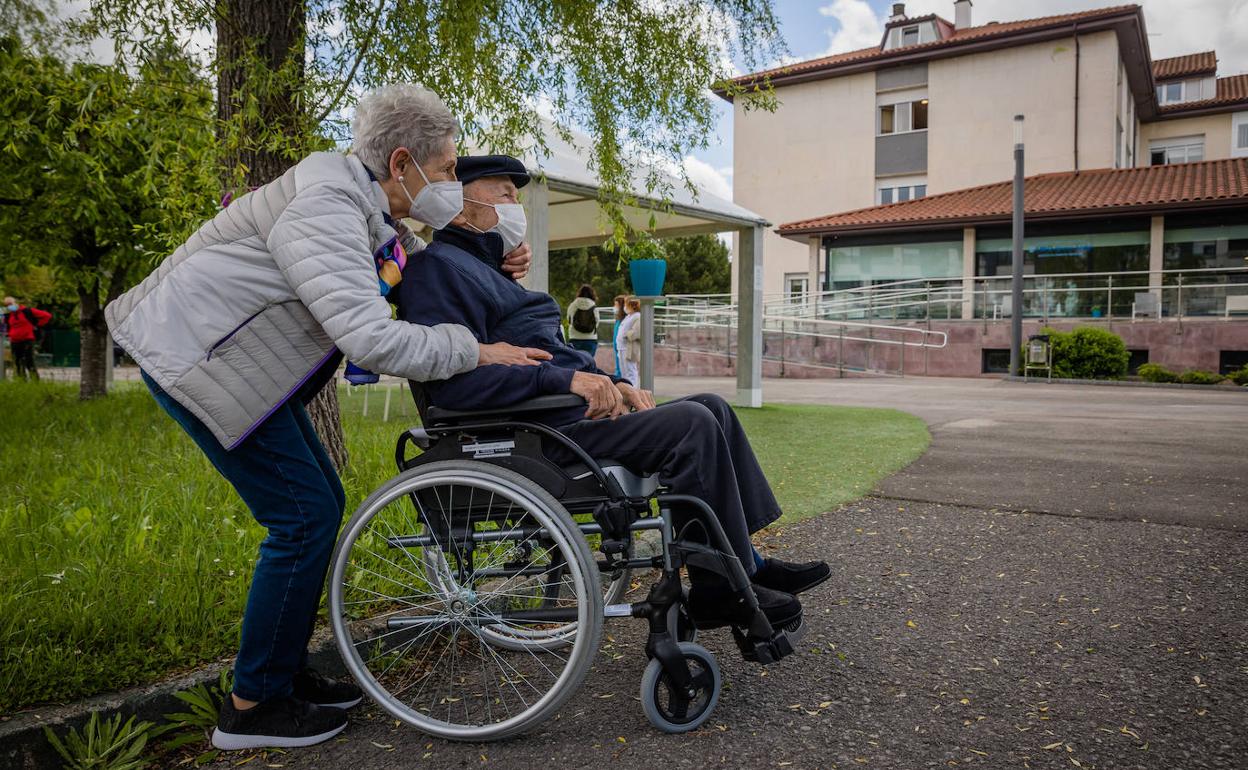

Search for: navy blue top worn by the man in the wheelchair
xmin=398 ymin=227 xmax=615 ymax=426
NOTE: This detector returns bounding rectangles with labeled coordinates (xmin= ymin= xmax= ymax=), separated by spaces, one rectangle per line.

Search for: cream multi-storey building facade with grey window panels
xmin=734 ymin=0 xmax=1248 ymax=303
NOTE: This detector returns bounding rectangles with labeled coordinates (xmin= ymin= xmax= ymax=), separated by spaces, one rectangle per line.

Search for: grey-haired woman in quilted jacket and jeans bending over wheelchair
xmin=106 ymin=85 xmax=549 ymax=749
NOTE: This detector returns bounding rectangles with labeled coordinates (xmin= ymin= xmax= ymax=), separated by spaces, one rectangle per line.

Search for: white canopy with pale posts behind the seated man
xmin=476 ymin=131 xmax=770 ymax=407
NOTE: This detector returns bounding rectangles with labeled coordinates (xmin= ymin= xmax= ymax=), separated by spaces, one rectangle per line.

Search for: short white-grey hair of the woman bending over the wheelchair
xmin=351 ymin=82 xmax=459 ymax=180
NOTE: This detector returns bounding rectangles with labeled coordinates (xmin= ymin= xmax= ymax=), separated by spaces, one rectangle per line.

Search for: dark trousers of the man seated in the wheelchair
xmin=552 ymin=393 xmax=780 ymax=566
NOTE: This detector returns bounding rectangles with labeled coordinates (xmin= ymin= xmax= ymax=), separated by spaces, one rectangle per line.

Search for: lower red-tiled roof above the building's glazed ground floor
xmin=780 ymin=157 xmax=1248 ymax=236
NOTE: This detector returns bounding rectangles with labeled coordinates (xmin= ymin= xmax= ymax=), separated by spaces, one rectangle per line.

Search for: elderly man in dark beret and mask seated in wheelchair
xmin=399 ymin=155 xmax=829 ymax=628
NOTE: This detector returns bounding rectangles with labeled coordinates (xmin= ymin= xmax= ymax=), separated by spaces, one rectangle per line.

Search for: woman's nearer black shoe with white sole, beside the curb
xmin=212 ymin=696 xmax=347 ymax=751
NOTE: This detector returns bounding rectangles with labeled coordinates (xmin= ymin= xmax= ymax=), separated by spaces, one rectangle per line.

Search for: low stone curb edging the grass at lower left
xmin=0 ymin=629 xmax=346 ymax=770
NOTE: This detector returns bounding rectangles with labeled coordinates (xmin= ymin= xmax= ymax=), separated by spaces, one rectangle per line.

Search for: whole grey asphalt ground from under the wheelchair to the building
xmin=204 ymin=378 xmax=1248 ymax=770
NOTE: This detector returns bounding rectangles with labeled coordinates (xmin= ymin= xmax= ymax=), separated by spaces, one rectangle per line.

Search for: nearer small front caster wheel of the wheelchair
xmin=641 ymin=641 xmax=723 ymax=733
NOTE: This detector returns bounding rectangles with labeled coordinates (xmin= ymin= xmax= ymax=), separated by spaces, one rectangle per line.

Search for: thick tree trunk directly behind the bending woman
xmin=217 ymin=0 xmax=348 ymax=470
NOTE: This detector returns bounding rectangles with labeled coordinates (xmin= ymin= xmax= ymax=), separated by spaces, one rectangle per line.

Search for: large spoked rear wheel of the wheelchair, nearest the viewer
xmin=329 ymin=461 xmax=603 ymax=741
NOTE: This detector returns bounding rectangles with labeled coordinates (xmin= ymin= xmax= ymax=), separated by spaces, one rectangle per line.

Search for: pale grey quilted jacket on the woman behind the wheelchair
xmin=105 ymin=152 xmax=478 ymax=449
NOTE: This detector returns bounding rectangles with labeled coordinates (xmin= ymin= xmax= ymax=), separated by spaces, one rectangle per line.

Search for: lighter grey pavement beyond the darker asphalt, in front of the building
xmin=656 ymin=377 xmax=1248 ymax=530
